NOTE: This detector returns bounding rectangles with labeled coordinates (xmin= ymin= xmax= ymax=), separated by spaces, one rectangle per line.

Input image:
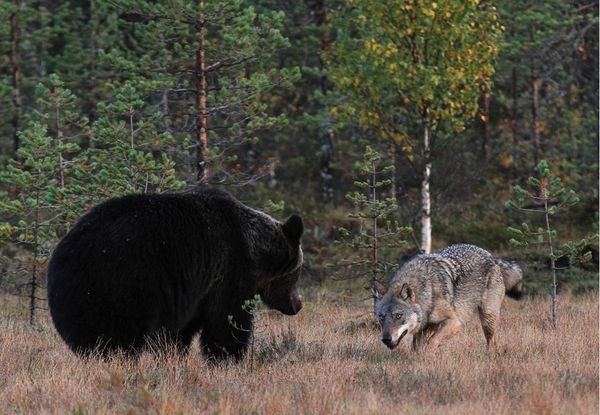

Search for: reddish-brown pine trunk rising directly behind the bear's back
xmin=196 ymin=0 xmax=208 ymax=183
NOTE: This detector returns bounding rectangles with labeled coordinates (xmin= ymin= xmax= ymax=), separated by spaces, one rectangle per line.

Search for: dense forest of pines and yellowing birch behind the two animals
xmin=0 ymin=0 xmax=599 ymax=316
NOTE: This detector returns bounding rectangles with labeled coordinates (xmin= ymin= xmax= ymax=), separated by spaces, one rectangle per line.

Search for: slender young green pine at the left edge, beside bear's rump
xmin=0 ymin=76 xmax=87 ymax=325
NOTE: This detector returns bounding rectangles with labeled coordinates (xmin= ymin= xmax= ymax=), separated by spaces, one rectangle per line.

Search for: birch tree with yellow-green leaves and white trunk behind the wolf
xmin=329 ymin=0 xmax=502 ymax=252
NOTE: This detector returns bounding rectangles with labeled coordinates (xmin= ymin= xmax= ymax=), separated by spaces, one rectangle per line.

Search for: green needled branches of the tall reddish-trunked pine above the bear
xmin=103 ymin=0 xmax=299 ymax=183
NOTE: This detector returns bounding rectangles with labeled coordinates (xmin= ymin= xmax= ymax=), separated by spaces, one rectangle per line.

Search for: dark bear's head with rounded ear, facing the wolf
xmin=257 ymin=215 xmax=304 ymax=315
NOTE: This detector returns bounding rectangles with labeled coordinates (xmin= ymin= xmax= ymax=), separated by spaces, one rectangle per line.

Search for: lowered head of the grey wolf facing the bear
xmin=372 ymin=282 xmax=421 ymax=349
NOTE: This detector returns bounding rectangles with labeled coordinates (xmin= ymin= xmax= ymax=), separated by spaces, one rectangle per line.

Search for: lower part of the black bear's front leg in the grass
xmin=200 ymin=309 xmax=253 ymax=361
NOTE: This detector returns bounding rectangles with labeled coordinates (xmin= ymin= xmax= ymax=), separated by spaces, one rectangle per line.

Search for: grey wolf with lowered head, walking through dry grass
xmin=373 ymin=244 xmax=522 ymax=349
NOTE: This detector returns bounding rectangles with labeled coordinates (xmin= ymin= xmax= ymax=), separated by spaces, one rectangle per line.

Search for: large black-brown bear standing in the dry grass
xmin=48 ymin=188 xmax=303 ymax=359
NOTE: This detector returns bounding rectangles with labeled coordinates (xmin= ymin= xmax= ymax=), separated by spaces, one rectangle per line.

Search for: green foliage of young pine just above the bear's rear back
xmin=80 ymin=82 xmax=185 ymax=200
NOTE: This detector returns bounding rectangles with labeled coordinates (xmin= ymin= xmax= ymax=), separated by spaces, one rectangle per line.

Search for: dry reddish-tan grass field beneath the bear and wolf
xmin=0 ymin=294 xmax=599 ymax=415
